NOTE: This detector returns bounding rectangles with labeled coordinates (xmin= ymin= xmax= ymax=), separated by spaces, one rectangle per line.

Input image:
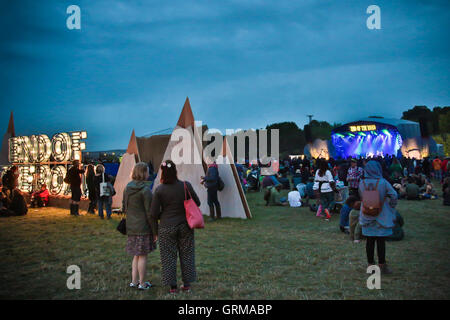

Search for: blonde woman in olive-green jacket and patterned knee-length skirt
xmin=122 ymin=162 xmax=157 ymax=290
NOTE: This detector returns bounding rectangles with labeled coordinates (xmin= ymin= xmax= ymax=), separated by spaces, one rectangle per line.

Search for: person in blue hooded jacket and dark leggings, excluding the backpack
xmin=358 ymin=160 xmax=397 ymax=274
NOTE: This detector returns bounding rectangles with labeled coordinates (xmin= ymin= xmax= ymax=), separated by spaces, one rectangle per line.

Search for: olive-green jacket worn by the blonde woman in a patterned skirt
xmin=122 ymin=180 xmax=152 ymax=235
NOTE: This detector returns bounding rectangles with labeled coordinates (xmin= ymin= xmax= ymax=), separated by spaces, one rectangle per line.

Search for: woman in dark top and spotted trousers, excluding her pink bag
xmin=150 ymin=160 xmax=200 ymax=294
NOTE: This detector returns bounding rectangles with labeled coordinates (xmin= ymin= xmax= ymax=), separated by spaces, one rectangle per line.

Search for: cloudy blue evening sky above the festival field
xmin=0 ymin=0 xmax=450 ymax=150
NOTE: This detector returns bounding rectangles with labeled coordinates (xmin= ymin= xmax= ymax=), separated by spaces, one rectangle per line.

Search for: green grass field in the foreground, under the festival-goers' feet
xmin=0 ymin=188 xmax=450 ymax=299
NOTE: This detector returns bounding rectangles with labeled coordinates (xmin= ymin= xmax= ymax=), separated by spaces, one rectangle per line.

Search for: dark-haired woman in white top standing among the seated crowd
xmin=313 ymin=159 xmax=337 ymax=221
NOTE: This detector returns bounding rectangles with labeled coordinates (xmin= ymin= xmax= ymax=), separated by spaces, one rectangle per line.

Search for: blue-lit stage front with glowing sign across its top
xmin=331 ymin=121 xmax=403 ymax=159
